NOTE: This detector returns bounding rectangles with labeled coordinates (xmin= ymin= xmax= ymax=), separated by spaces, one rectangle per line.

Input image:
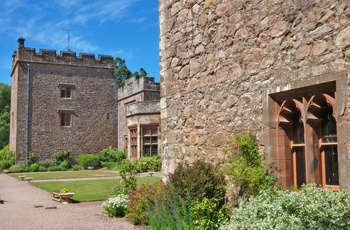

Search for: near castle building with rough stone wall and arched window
xmin=158 ymin=0 xmax=350 ymax=191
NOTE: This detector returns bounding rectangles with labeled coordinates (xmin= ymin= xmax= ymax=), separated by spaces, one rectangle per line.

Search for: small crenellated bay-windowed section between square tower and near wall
xmin=118 ymin=76 xmax=161 ymax=159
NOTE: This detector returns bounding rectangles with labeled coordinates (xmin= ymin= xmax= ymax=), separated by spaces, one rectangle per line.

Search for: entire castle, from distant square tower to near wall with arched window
xmin=10 ymin=0 xmax=350 ymax=192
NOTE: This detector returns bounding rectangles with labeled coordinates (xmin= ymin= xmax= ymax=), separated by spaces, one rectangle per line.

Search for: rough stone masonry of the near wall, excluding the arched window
xmin=159 ymin=0 xmax=350 ymax=188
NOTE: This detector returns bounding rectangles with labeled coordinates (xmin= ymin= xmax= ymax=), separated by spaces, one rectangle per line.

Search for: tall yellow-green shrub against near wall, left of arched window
xmin=223 ymin=133 xmax=276 ymax=199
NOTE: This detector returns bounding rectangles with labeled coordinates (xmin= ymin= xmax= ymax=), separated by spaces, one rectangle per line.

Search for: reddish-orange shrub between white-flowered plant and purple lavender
xmin=126 ymin=181 xmax=169 ymax=224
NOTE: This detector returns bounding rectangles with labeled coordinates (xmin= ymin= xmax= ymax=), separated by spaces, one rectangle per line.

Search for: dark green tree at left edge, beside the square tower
xmin=0 ymin=83 xmax=11 ymax=149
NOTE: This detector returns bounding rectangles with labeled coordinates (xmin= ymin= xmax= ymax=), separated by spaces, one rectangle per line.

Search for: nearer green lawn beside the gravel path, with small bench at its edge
xmin=31 ymin=174 xmax=161 ymax=202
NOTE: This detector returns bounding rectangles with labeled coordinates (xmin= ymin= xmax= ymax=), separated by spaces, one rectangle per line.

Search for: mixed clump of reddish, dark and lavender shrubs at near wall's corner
xmin=127 ymin=161 xmax=226 ymax=229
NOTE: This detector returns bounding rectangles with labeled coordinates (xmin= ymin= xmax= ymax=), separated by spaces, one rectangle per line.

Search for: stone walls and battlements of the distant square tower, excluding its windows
xmin=10 ymin=39 xmax=118 ymax=162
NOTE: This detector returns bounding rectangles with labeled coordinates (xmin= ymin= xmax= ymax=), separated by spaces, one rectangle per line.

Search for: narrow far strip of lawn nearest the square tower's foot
xmin=8 ymin=170 xmax=119 ymax=180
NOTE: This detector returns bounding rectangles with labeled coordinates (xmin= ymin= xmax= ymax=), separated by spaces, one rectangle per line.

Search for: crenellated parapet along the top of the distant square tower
xmin=12 ymin=38 xmax=114 ymax=68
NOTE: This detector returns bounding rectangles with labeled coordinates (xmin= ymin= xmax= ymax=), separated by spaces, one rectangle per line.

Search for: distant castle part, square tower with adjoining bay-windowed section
xmin=10 ymin=38 xmax=160 ymax=163
